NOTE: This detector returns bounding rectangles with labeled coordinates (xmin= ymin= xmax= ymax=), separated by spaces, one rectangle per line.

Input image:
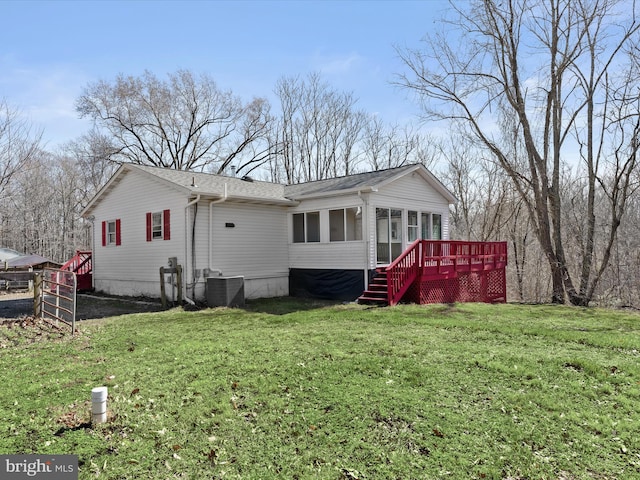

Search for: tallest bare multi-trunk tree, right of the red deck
xmin=399 ymin=0 xmax=639 ymax=305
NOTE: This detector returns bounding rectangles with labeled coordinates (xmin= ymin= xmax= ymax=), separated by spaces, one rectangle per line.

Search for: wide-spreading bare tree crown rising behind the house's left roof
xmin=76 ymin=70 xmax=270 ymax=173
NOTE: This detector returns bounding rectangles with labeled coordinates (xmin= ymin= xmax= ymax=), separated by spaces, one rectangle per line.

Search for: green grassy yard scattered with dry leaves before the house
xmin=0 ymin=300 xmax=640 ymax=480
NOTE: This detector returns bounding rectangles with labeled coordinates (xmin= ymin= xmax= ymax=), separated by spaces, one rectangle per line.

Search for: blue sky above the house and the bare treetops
xmin=0 ymin=0 xmax=447 ymax=148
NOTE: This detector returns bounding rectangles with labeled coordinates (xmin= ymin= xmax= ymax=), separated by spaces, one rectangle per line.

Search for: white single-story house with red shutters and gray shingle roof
xmin=82 ymin=164 xmax=455 ymax=301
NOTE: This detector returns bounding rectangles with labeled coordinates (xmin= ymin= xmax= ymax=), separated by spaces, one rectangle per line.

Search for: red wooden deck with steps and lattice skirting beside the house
xmin=359 ymin=240 xmax=507 ymax=305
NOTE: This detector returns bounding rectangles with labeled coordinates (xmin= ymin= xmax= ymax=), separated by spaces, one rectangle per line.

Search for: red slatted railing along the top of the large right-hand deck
xmin=386 ymin=240 xmax=507 ymax=305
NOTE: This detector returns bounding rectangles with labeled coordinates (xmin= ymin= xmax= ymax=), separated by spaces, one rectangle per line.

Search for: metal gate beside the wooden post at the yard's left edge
xmin=34 ymin=268 xmax=77 ymax=333
